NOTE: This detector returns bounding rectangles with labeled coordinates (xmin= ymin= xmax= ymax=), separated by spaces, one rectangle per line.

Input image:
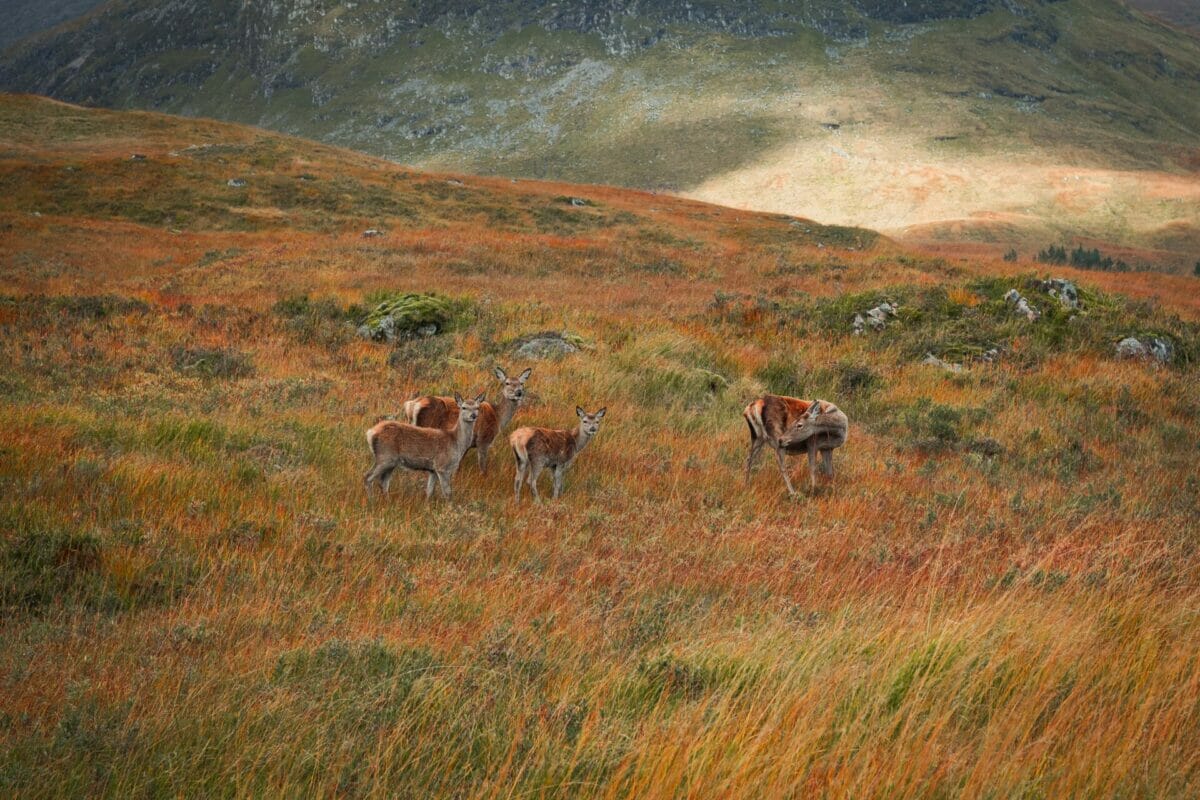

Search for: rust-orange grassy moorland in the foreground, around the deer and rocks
xmin=7 ymin=96 xmax=1200 ymax=798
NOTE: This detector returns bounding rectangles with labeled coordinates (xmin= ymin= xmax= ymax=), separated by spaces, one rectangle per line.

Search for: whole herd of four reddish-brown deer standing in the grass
xmin=364 ymin=367 xmax=850 ymax=503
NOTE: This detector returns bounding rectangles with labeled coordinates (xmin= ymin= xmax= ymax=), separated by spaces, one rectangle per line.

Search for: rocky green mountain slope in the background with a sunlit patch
xmin=0 ymin=0 xmax=1200 ymax=262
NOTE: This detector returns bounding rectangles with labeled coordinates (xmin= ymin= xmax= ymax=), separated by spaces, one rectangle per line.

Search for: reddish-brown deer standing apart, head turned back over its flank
xmin=742 ymin=395 xmax=850 ymax=497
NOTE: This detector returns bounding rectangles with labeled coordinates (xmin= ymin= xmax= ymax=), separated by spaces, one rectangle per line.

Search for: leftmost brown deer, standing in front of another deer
xmin=364 ymin=392 xmax=484 ymax=500
